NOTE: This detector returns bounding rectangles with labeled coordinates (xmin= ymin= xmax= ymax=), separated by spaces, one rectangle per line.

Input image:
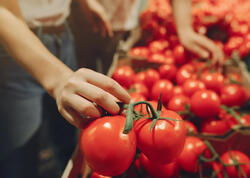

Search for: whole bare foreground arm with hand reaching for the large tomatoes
xmin=0 ymin=0 xmax=130 ymax=127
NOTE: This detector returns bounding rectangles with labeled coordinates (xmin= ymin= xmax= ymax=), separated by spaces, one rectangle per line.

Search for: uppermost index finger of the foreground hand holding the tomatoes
xmin=84 ymin=70 xmax=133 ymax=104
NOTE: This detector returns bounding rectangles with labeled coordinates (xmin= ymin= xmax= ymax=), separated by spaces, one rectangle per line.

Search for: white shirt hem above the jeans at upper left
xmin=18 ymin=0 xmax=71 ymax=27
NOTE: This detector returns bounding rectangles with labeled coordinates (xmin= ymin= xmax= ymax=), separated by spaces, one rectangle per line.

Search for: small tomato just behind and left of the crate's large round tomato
xmin=182 ymin=79 xmax=205 ymax=97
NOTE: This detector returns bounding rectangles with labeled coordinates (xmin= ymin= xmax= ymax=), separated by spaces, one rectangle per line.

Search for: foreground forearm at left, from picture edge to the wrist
xmin=0 ymin=7 xmax=72 ymax=96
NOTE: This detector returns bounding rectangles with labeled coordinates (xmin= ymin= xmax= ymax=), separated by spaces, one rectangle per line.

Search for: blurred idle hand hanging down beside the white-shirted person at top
xmin=80 ymin=0 xmax=113 ymax=37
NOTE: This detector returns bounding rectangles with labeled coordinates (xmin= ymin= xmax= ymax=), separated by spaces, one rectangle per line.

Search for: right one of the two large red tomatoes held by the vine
xmin=134 ymin=110 xmax=186 ymax=164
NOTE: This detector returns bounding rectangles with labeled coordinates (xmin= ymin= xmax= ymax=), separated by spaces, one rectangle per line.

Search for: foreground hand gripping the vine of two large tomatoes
xmin=54 ymin=68 xmax=130 ymax=128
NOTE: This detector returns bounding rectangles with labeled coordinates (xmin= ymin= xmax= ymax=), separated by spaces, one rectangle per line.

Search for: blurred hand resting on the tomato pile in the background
xmin=179 ymin=30 xmax=223 ymax=66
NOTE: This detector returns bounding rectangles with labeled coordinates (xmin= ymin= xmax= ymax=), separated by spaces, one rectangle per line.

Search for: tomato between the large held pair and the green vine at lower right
xmin=177 ymin=137 xmax=207 ymax=173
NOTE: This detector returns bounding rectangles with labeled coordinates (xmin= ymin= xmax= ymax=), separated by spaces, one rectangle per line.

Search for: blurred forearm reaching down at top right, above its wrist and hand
xmin=171 ymin=0 xmax=192 ymax=34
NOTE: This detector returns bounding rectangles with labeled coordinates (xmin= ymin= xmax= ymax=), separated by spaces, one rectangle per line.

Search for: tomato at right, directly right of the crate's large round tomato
xmin=220 ymin=84 xmax=247 ymax=106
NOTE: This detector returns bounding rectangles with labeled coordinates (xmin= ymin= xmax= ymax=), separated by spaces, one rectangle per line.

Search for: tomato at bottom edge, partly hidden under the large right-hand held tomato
xmin=140 ymin=153 xmax=179 ymax=178
